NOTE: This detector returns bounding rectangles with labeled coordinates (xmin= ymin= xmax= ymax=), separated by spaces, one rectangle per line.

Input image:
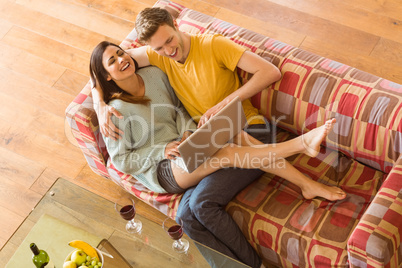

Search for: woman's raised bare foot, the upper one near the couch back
xmin=301 ymin=118 xmax=336 ymax=157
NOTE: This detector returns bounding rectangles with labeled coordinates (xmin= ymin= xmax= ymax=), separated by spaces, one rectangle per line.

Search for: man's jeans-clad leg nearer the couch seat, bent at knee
xmin=189 ymin=168 xmax=264 ymax=267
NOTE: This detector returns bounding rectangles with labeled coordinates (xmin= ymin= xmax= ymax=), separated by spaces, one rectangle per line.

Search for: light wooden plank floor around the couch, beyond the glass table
xmin=0 ymin=0 xmax=402 ymax=260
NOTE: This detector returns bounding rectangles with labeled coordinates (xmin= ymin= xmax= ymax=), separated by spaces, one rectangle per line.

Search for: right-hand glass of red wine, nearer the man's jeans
xmin=162 ymin=217 xmax=190 ymax=253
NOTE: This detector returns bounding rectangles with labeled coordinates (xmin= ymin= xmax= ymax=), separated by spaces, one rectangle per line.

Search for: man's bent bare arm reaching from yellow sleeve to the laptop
xmin=198 ymin=51 xmax=281 ymax=127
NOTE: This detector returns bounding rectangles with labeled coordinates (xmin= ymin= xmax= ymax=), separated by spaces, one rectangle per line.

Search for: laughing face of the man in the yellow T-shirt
xmin=147 ymin=22 xmax=188 ymax=63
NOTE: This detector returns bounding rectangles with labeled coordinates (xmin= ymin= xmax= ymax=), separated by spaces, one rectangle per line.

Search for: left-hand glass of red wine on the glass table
xmin=114 ymin=197 xmax=142 ymax=233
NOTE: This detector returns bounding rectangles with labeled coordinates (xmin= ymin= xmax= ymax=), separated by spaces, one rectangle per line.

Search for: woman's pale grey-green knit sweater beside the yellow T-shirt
xmin=103 ymin=66 xmax=196 ymax=193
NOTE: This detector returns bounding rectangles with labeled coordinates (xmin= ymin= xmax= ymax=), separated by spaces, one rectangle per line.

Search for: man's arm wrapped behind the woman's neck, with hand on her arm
xmin=92 ymin=46 xmax=149 ymax=140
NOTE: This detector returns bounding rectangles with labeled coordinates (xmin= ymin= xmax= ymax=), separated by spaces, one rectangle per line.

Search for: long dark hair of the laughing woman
xmin=89 ymin=41 xmax=149 ymax=104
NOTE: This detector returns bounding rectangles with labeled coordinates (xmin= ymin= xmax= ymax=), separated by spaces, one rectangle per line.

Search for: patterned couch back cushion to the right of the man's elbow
xmin=261 ymin=49 xmax=402 ymax=173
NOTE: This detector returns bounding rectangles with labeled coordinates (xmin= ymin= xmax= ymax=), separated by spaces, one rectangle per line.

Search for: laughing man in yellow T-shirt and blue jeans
xmin=93 ymin=8 xmax=342 ymax=267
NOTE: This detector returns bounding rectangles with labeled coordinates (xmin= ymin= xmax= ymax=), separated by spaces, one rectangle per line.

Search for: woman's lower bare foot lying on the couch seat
xmin=302 ymin=180 xmax=346 ymax=201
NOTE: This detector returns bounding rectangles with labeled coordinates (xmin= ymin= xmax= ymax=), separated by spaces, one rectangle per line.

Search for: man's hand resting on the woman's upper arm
xmin=98 ymin=103 xmax=124 ymax=140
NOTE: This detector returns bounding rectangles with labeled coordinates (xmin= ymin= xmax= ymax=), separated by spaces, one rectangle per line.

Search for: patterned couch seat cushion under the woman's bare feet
xmin=227 ymin=133 xmax=386 ymax=267
